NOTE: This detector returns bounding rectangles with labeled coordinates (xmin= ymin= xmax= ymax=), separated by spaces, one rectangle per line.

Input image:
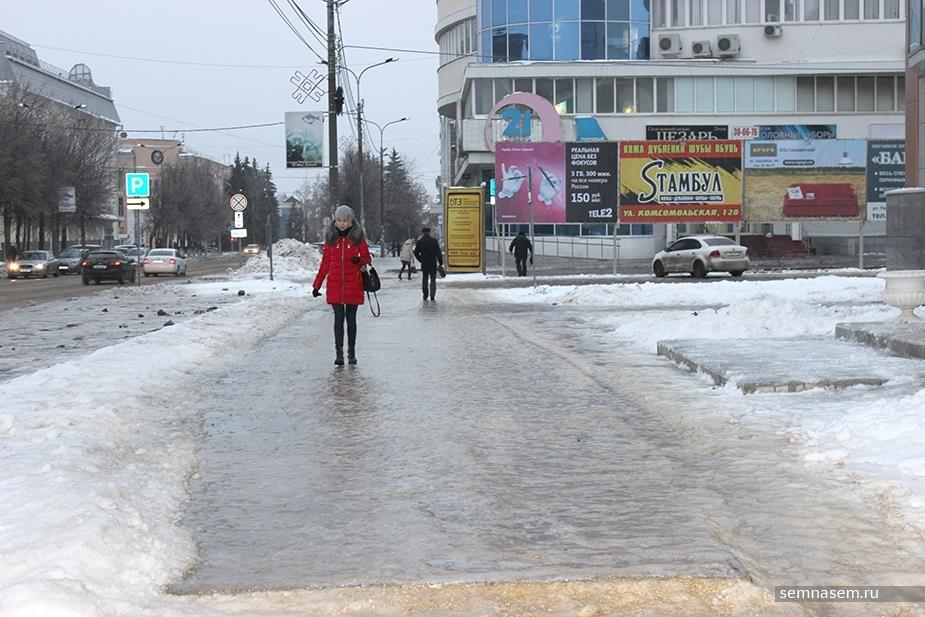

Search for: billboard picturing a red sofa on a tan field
xmin=745 ymin=139 xmax=867 ymax=222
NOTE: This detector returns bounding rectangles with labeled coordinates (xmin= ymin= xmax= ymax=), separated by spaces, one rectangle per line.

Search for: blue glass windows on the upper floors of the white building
xmin=478 ymin=0 xmax=649 ymax=62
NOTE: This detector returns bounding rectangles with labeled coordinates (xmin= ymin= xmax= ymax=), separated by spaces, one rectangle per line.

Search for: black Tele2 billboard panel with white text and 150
xmin=565 ymin=142 xmax=617 ymax=223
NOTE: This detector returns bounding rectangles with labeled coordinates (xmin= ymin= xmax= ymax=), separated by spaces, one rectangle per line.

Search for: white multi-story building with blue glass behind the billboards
xmin=436 ymin=0 xmax=904 ymax=257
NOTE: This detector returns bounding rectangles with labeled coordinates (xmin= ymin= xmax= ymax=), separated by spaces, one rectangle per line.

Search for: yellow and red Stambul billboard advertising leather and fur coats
xmin=620 ymin=140 xmax=742 ymax=224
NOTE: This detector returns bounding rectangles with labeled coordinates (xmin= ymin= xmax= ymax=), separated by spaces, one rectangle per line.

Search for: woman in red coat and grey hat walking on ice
xmin=312 ymin=206 xmax=373 ymax=366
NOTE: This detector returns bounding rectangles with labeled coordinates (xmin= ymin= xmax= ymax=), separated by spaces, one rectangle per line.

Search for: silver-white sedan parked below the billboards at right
xmin=652 ymin=236 xmax=749 ymax=278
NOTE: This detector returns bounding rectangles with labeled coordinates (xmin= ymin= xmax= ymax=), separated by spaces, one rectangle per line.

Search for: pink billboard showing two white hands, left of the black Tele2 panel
xmin=495 ymin=141 xmax=566 ymax=223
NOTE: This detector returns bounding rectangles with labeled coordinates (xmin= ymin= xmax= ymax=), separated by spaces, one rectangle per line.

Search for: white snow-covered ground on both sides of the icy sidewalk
xmin=0 ymin=245 xmax=925 ymax=617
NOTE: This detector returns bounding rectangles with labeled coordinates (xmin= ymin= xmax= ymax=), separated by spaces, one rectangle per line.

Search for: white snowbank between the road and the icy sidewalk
xmin=0 ymin=286 xmax=309 ymax=617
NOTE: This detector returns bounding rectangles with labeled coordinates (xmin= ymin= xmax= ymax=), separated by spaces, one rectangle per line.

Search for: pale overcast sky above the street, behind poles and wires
xmin=0 ymin=0 xmax=440 ymax=194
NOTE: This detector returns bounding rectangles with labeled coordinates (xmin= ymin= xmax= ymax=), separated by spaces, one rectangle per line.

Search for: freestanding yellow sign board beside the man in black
xmin=443 ymin=187 xmax=485 ymax=272
